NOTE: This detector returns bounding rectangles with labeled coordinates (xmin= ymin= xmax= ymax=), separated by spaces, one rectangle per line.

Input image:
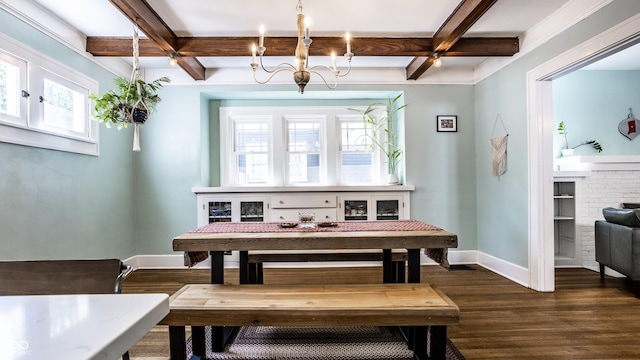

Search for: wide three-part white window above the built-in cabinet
xmin=220 ymin=106 xmax=398 ymax=186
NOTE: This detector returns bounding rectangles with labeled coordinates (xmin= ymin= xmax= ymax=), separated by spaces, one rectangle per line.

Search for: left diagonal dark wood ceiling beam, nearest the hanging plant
xmin=109 ymin=0 xmax=205 ymax=80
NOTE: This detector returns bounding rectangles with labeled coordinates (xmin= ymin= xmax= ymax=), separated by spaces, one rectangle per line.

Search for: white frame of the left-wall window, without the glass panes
xmin=0 ymin=34 xmax=100 ymax=156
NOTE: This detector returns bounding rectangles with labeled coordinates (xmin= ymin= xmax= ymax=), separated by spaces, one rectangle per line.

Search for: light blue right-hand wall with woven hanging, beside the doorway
xmin=474 ymin=0 xmax=640 ymax=267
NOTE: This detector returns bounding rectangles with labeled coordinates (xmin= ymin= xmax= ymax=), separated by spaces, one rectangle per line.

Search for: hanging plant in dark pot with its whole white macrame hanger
xmin=89 ymin=25 xmax=170 ymax=151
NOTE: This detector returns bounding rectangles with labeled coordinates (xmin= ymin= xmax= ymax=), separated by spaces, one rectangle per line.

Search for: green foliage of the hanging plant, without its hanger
xmin=89 ymin=76 xmax=171 ymax=130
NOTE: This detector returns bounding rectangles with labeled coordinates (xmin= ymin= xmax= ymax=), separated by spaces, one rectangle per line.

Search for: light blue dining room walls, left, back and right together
xmin=5 ymin=0 xmax=640 ymax=267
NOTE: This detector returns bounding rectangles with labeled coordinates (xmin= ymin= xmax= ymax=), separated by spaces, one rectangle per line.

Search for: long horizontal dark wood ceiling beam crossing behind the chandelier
xmin=86 ymin=37 xmax=519 ymax=57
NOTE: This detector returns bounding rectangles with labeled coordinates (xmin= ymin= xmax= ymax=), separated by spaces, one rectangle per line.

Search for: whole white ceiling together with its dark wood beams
xmin=20 ymin=0 xmax=608 ymax=83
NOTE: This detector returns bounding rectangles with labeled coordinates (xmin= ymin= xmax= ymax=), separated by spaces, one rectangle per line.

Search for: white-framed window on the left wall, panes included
xmin=0 ymin=34 xmax=98 ymax=155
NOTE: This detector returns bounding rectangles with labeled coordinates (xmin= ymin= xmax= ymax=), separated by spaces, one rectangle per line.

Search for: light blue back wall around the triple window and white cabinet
xmin=135 ymin=85 xmax=476 ymax=254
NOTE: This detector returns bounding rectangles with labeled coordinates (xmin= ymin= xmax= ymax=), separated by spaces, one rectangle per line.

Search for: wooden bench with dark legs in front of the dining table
xmin=159 ymin=284 xmax=460 ymax=360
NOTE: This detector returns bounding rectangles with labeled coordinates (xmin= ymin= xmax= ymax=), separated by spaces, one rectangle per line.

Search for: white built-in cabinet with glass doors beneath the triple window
xmin=193 ymin=185 xmax=414 ymax=226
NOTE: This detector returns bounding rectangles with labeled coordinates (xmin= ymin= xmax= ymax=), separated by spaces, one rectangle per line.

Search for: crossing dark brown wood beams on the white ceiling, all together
xmin=86 ymin=0 xmax=519 ymax=80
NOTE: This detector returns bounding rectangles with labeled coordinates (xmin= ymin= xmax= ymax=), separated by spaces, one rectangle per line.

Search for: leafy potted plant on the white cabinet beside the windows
xmin=349 ymin=94 xmax=407 ymax=184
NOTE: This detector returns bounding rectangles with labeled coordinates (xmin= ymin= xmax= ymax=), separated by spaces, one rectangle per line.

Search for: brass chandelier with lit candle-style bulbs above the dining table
xmin=251 ymin=0 xmax=353 ymax=94
